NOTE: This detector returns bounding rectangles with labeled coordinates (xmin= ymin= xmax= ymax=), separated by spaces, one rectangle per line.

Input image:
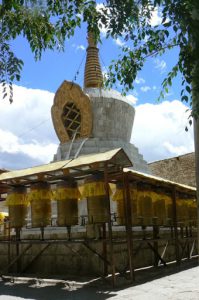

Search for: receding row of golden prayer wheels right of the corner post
xmin=113 ymin=186 xmax=197 ymax=225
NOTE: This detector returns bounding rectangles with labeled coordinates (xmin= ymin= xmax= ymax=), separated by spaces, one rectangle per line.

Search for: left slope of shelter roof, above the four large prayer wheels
xmin=0 ymin=148 xmax=132 ymax=185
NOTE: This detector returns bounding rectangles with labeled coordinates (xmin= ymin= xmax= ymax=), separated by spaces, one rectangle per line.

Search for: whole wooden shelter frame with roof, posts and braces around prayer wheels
xmin=0 ymin=149 xmax=197 ymax=286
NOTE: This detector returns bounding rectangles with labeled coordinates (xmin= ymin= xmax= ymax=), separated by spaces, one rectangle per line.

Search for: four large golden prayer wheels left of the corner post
xmin=6 ymin=176 xmax=109 ymax=228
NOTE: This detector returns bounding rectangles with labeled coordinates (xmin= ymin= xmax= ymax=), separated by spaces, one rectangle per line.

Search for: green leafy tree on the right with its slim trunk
xmin=102 ymin=0 xmax=199 ymax=244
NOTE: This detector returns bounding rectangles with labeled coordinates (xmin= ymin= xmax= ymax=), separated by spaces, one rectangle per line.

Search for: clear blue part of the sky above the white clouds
xmin=12 ymin=20 xmax=180 ymax=103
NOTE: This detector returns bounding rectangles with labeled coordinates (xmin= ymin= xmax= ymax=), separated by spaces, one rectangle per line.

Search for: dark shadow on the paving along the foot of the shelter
xmin=0 ymin=258 xmax=198 ymax=300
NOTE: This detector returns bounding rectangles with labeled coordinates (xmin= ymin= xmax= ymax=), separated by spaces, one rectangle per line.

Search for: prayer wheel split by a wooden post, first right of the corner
xmin=113 ymin=184 xmax=138 ymax=225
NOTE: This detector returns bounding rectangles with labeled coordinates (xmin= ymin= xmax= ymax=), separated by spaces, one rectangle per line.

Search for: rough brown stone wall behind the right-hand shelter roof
xmin=148 ymin=152 xmax=196 ymax=186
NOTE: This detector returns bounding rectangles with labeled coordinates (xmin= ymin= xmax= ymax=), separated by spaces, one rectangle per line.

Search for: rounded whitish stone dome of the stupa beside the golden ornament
xmin=85 ymin=88 xmax=135 ymax=142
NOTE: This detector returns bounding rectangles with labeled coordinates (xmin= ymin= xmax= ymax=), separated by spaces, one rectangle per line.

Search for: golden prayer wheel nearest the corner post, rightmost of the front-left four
xmin=82 ymin=175 xmax=109 ymax=224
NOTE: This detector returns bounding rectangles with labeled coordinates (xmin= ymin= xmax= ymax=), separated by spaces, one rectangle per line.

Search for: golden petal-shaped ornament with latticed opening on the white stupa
xmin=51 ymin=81 xmax=92 ymax=143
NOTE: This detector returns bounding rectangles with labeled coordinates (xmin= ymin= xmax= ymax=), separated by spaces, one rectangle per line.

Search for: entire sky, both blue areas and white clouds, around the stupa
xmin=0 ymin=6 xmax=193 ymax=169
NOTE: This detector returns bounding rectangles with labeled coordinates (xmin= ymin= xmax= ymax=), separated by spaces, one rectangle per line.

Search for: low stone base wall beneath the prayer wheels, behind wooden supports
xmin=0 ymin=226 xmax=191 ymax=276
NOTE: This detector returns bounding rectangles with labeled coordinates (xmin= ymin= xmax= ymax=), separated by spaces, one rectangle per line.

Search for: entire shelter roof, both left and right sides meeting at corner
xmin=0 ymin=148 xmax=196 ymax=197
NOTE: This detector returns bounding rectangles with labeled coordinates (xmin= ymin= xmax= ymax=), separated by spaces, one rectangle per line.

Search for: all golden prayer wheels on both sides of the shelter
xmin=6 ymin=176 xmax=197 ymax=228
